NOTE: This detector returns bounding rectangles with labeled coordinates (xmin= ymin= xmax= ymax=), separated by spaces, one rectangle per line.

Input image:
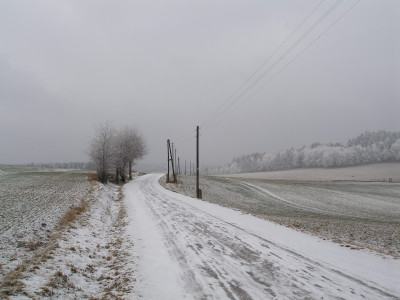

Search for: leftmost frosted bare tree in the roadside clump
xmin=89 ymin=121 xmax=115 ymax=183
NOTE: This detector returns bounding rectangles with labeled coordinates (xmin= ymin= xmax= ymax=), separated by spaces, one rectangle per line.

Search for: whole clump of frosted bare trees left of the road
xmin=88 ymin=122 xmax=148 ymax=183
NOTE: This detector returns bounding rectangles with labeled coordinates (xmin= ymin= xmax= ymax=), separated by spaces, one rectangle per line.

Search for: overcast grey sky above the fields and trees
xmin=0 ymin=0 xmax=400 ymax=169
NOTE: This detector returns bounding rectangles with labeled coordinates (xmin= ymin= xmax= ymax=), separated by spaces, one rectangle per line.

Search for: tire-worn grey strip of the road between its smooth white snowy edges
xmin=126 ymin=175 xmax=395 ymax=299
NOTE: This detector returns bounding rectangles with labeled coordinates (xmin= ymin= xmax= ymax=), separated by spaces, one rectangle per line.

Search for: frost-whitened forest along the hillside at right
xmin=204 ymin=131 xmax=400 ymax=175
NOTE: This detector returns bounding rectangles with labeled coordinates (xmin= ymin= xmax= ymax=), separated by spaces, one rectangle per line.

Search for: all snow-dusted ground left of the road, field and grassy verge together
xmin=0 ymin=166 xmax=136 ymax=299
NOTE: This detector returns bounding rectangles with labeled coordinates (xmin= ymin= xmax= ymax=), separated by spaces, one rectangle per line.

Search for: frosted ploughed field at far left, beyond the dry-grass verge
xmin=0 ymin=166 xmax=90 ymax=281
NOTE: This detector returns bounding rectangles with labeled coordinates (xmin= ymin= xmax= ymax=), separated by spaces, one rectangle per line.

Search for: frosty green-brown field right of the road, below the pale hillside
xmin=168 ymin=166 xmax=400 ymax=257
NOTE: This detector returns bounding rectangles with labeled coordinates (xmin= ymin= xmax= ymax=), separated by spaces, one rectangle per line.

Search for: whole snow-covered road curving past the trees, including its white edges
xmin=124 ymin=174 xmax=400 ymax=299
